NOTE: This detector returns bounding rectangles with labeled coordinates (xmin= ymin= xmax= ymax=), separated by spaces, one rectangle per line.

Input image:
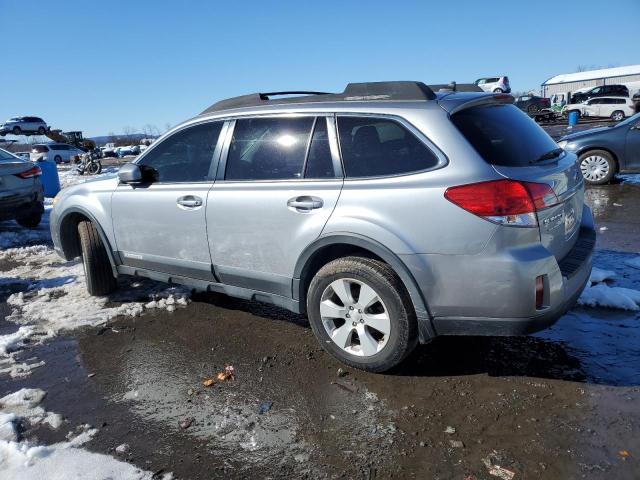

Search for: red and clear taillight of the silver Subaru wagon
xmin=444 ymin=179 xmax=558 ymax=227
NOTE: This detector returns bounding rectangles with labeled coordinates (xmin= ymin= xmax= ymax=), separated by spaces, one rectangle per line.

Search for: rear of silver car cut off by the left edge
xmin=0 ymin=148 xmax=44 ymax=228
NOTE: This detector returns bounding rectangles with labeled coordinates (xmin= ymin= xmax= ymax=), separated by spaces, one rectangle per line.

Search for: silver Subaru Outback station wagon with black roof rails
xmin=50 ymin=82 xmax=595 ymax=371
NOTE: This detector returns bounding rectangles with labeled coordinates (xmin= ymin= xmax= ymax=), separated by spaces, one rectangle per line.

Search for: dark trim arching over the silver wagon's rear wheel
xmin=292 ymin=232 xmax=436 ymax=343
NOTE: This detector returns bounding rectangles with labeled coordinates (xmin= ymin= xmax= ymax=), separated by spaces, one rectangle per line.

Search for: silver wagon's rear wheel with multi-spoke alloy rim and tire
xmin=307 ymin=257 xmax=417 ymax=372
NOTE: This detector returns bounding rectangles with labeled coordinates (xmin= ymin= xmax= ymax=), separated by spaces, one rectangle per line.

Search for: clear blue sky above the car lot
xmin=0 ymin=0 xmax=640 ymax=136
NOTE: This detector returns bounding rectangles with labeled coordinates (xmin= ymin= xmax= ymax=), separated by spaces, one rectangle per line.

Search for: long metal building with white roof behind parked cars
xmin=541 ymin=65 xmax=640 ymax=97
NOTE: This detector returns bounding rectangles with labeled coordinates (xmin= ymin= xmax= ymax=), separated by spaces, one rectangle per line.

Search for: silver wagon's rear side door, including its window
xmin=207 ymin=114 xmax=343 ymax=297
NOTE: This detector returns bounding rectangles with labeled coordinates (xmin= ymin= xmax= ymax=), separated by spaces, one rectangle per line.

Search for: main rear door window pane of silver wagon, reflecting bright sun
xmin=225 ymin=117 xmax=319 ymax=180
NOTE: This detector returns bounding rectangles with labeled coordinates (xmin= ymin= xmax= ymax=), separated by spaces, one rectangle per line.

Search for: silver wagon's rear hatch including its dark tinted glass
xmin=451 ymin=99 xmax=584 ymax=260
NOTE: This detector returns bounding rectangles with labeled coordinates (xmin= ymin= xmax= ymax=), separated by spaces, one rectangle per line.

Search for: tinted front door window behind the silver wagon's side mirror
xmin=138 ymin=122 xmax=222 ymax=183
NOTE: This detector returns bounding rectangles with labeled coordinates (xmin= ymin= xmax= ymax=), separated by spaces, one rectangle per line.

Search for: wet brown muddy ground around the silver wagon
xmin=0 ymin=129 xmax=640 ymax=480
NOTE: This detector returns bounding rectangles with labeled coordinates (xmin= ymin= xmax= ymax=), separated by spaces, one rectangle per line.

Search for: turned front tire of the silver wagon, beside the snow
xmin=78 ymin=221 xmax=118 ymax=296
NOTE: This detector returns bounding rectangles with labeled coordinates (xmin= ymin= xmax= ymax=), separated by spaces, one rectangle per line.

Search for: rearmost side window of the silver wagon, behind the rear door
xmin=338 ymin=116 xmax=438 ymax=178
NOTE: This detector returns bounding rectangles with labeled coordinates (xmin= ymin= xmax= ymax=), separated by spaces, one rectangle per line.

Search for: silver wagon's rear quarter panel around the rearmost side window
xmin=323 ymin=102 xmax=499 ymax=254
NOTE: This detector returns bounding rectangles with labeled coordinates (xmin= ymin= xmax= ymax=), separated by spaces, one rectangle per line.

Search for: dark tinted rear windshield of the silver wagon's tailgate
xmin=451 ymin=105 xmax=558 ymax=167
